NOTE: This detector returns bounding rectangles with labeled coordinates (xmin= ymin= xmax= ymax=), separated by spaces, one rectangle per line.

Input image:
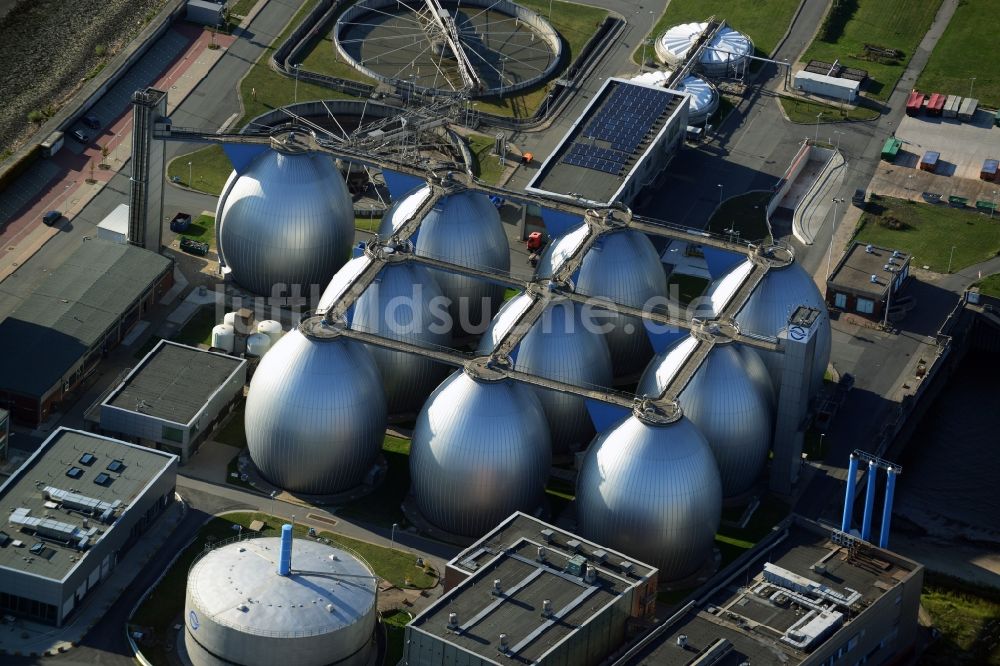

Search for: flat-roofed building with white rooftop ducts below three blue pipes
xmin=615 ymin=516 xmax=923 ymax=666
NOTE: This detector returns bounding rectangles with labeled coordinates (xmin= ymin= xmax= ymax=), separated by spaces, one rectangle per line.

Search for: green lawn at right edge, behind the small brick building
xmin=854 ymin=197 xmax=1000 ymax=273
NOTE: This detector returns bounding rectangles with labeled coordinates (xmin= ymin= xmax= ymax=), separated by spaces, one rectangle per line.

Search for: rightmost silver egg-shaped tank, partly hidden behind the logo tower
xmin=707 ymin=260 xmax=832 ymax=395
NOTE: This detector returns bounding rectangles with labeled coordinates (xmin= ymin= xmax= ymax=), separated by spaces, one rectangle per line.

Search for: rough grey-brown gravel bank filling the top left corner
xmin=0 ymin=0 xmax=165 ymax=153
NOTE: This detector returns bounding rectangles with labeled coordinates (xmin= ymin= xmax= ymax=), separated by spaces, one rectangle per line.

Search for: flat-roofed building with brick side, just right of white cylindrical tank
xmin=403 ymin=512 xmax=657 ymax=666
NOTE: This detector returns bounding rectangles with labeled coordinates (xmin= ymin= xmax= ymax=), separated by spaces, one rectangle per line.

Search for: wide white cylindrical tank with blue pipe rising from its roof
xmin=184 ymin=537 xmax=378 ymax=666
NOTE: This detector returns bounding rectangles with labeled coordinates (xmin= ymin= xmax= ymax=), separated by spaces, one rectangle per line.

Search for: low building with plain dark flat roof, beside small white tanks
xmin=100 ymin=340 xmax=247 ymax=463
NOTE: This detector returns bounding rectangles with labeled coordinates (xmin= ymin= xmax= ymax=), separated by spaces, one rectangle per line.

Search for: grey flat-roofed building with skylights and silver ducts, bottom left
xmin=0 ymin=428 xmax=177 ymax=625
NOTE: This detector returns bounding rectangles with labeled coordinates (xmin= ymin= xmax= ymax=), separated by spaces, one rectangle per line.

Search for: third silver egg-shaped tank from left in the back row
xmin=535 ymin=227 xmax=667 ymax=377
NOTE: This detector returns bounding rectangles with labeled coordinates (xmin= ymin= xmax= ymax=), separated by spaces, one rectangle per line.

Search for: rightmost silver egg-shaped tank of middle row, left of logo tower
xmin=636 ymin=336 xmax=774 ymax=497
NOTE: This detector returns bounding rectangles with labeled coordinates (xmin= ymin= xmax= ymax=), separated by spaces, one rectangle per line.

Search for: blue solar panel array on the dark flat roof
xmin=562 ymin=85 xmax=672 ymax=175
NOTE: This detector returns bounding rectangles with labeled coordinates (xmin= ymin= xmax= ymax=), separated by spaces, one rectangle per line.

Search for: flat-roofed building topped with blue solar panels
xmin=525 ymin=78 xmax=689 ymax=205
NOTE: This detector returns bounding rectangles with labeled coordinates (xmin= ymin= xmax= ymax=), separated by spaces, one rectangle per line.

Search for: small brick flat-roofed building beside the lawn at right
xmin=826 ymin=242 xmax=910 ymax=320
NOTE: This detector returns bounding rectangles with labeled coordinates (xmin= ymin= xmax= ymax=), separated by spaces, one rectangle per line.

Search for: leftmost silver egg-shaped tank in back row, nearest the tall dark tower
xmin=216 ymin=150 xmax=354 ymax=296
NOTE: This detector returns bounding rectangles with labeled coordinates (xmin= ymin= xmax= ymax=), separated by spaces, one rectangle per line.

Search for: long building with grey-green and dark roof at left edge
xmin=0 ymin=240 xmax=173 ymax=426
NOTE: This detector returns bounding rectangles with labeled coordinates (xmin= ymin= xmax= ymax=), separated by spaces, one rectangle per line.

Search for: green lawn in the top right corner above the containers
xmin=916 ymin=0 xmax=1000 ymax=108
